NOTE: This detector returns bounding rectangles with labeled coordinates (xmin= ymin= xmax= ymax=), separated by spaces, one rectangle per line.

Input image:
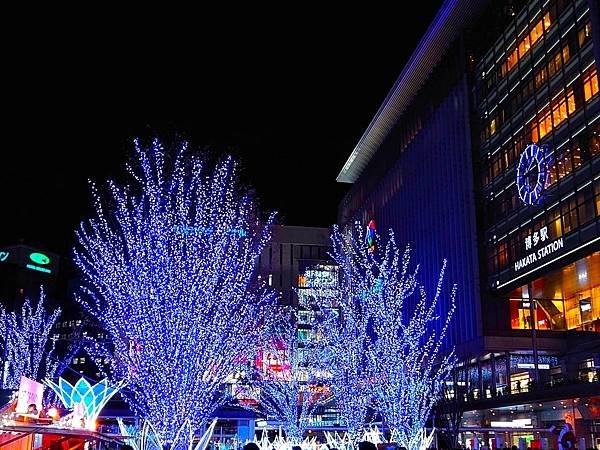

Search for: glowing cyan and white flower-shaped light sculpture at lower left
xmin=44 ymin=378 xmax=121 ymax=429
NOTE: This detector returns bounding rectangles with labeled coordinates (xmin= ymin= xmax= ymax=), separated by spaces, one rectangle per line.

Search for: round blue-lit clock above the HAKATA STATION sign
xmin=517 ymin=144 xmax=548 ymax=205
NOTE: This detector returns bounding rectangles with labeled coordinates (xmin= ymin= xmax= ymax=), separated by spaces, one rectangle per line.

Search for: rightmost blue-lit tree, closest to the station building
xmin=368 ymin=232 xmax=456 ymax=450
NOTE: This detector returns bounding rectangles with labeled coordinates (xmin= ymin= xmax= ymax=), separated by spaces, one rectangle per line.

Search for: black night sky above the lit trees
xmin=0 ymin=6 xmax=441 ymax=254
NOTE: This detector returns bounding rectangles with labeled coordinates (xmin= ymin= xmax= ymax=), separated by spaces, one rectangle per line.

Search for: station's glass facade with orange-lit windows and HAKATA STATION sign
xmin=476 ymin=0 xmax=600 ymax=294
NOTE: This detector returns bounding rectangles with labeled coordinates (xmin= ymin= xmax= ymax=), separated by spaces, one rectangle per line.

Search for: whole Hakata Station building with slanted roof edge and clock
xmin=338 ymin=0 xmax=600 ymax=448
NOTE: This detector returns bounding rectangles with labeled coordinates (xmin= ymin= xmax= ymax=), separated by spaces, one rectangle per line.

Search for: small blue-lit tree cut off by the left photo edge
xmin=0 ymin=289 xmax=60 ymax=389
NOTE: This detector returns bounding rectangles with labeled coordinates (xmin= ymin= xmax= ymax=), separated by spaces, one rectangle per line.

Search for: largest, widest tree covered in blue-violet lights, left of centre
xmin=74 ymin=141 xmax=275 ymax=442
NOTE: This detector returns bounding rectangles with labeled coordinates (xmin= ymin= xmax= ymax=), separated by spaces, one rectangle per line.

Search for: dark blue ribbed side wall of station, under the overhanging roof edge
xmin=340 ymin=76 xmax=482 ymax=354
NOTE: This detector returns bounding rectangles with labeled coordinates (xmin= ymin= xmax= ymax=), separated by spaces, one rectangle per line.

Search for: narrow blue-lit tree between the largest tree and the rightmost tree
xmin=311 ymin=223 xmax=377 ymax=443
